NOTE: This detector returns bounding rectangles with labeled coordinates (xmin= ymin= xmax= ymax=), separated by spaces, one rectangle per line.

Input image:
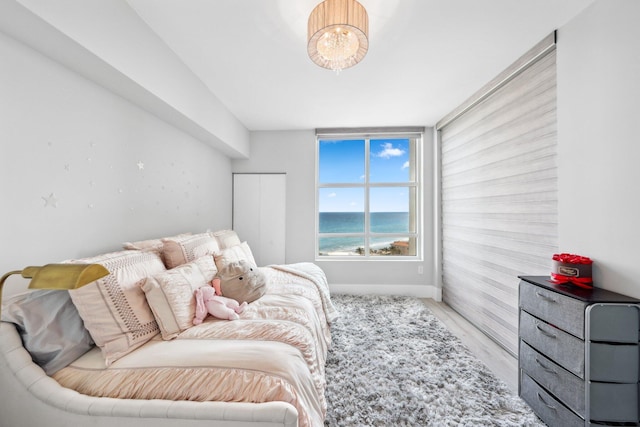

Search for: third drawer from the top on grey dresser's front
xmin=520 ymin=341 xmax=584 ymax=416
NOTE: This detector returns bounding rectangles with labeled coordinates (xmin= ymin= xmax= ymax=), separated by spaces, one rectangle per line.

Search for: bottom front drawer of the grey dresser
xmin=520 ymin=371 xmax=584 ymax=427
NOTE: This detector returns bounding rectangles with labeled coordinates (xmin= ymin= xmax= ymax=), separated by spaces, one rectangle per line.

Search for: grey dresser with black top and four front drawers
xmin=518 ymin=276 xmax=640 ymax=427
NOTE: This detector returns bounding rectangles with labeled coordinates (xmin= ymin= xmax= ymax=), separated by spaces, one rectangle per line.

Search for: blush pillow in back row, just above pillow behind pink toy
xmin=162 ymin=233 xmax=220 ymax=268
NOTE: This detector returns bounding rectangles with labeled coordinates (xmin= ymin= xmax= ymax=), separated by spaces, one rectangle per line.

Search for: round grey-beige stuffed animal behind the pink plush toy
xmin=217 ymin=260 xmax=267 ymax=303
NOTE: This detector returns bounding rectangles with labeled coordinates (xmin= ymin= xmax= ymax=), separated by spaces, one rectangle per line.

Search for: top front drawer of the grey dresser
xmin=520 ymin=280 xmax=587 ymax=339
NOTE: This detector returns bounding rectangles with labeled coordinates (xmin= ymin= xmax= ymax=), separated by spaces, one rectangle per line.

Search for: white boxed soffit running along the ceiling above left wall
xmin=0 ymin=0 xmax=249 ymax=157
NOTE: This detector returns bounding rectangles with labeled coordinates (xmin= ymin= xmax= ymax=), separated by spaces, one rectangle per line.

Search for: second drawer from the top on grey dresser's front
xmin=520 ymin=310 xmax=584 ymax=379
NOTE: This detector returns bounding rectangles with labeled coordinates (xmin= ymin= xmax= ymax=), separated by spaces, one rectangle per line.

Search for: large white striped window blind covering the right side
xmin=436 ymin=34 xmax=558 ymax=355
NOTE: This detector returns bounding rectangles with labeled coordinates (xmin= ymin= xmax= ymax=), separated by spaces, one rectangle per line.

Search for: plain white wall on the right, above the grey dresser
xmin=558 ymin=0 xmax=640 ymax=298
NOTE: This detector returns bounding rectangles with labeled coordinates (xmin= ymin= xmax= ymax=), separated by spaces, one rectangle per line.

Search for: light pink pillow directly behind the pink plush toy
xmin=142 ymin=256 xmax=218 ymax=340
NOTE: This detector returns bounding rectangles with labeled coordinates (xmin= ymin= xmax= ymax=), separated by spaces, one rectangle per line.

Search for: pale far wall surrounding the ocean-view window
xmin=232 ymin=129 xmax=439 ymax=297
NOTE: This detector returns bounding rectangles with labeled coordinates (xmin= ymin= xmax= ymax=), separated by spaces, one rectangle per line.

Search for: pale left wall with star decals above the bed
xmin=0 ymin=32 xmax=231 ymax=272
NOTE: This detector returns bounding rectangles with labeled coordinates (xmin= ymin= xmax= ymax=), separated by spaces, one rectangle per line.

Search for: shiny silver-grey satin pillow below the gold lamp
xmin=2 ymin=290 xmax=94 ymax=375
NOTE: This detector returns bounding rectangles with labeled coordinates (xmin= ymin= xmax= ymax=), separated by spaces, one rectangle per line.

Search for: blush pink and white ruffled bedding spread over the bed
xmin=52 ymin=263 xmax=337 ymax=427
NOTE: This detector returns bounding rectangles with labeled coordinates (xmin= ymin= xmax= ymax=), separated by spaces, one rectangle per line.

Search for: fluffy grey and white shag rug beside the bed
xmin=325 ymin=294 xmax=544 ymax=427
